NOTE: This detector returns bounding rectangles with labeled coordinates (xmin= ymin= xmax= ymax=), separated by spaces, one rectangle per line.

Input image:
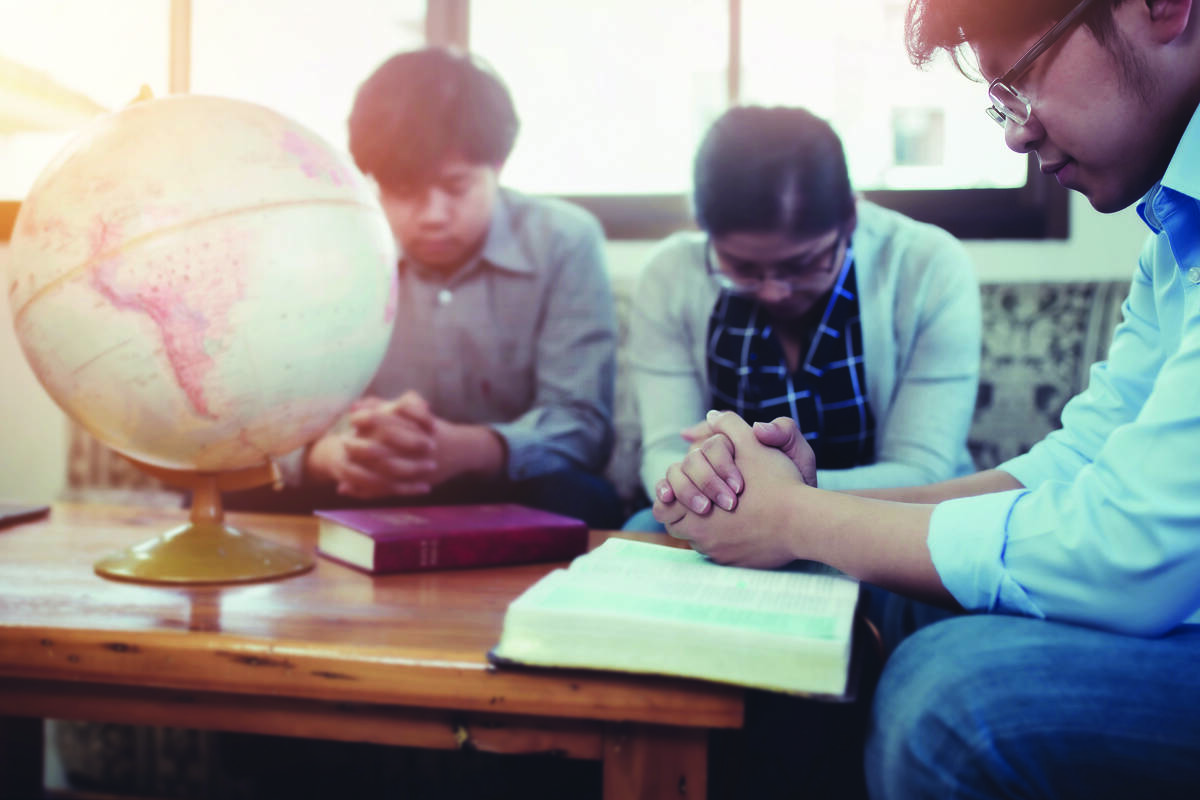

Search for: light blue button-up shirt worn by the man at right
xmin=928 ymin=103 xmax=1200 ymax=636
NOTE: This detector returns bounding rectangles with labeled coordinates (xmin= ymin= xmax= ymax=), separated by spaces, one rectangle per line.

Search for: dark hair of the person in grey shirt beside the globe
xmin=349 ymin=47 xmax=518 ymax=186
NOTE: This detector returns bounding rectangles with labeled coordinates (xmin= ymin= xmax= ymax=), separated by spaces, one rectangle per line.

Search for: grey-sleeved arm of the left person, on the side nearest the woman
xmin=491 ymin=214 xmax=617 ymax=480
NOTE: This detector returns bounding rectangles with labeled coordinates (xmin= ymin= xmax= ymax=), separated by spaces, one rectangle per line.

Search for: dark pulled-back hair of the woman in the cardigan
xmin=692 ymin=106 xmax=854 ymax=236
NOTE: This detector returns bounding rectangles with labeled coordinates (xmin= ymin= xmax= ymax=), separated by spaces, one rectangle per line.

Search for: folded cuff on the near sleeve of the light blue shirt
xmin=926 ymin=491 xmax=1042 ymax=616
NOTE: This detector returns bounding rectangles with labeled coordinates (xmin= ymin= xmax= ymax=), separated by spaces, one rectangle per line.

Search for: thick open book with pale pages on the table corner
xmin=488 ymin=539 xmax=859 ymax=697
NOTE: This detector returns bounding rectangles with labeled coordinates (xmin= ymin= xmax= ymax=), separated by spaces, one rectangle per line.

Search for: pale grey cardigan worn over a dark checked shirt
xmin=629 ymin=200 xmax=980 ymax=497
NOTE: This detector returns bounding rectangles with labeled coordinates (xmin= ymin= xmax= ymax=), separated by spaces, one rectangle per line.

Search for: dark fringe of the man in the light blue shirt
xmin=905 ymin=0 xmax=1124 ymax=76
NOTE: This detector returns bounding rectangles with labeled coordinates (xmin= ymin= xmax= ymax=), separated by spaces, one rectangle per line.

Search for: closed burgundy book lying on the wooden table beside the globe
xmin=314 ymin=503 xmax=588 ymax=575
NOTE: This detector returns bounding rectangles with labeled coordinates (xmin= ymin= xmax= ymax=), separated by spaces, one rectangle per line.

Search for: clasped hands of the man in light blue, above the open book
xmin=653 ymin=411 xmax=817 ymax=567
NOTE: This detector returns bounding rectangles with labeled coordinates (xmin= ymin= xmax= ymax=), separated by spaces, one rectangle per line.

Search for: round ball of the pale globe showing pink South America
xmin=5 ymin=95 xmax=397 ymax=585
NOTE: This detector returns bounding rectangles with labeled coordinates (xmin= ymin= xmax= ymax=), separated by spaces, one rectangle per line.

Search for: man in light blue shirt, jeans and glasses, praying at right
xmin=655 ymin=0 xmax=1200 ymax=799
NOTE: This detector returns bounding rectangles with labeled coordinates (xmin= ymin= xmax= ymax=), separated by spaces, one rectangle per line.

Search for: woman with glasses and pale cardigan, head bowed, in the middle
xmin=626 ymin=106 xmax=980 ymax=530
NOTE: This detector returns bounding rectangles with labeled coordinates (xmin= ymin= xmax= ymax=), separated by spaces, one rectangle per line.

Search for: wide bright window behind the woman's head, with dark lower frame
xmin=468 ymin=0 xmax=1067 ymax=237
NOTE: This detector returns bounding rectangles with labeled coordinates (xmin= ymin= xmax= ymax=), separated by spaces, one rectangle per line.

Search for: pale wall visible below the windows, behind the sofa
xmin=0 ymin=196 xmax=1146 ymax=500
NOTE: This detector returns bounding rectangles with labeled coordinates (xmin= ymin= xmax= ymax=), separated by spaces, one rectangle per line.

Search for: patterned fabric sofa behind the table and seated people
xmin=54 ymin=276 xmax=1128 ymax=798
